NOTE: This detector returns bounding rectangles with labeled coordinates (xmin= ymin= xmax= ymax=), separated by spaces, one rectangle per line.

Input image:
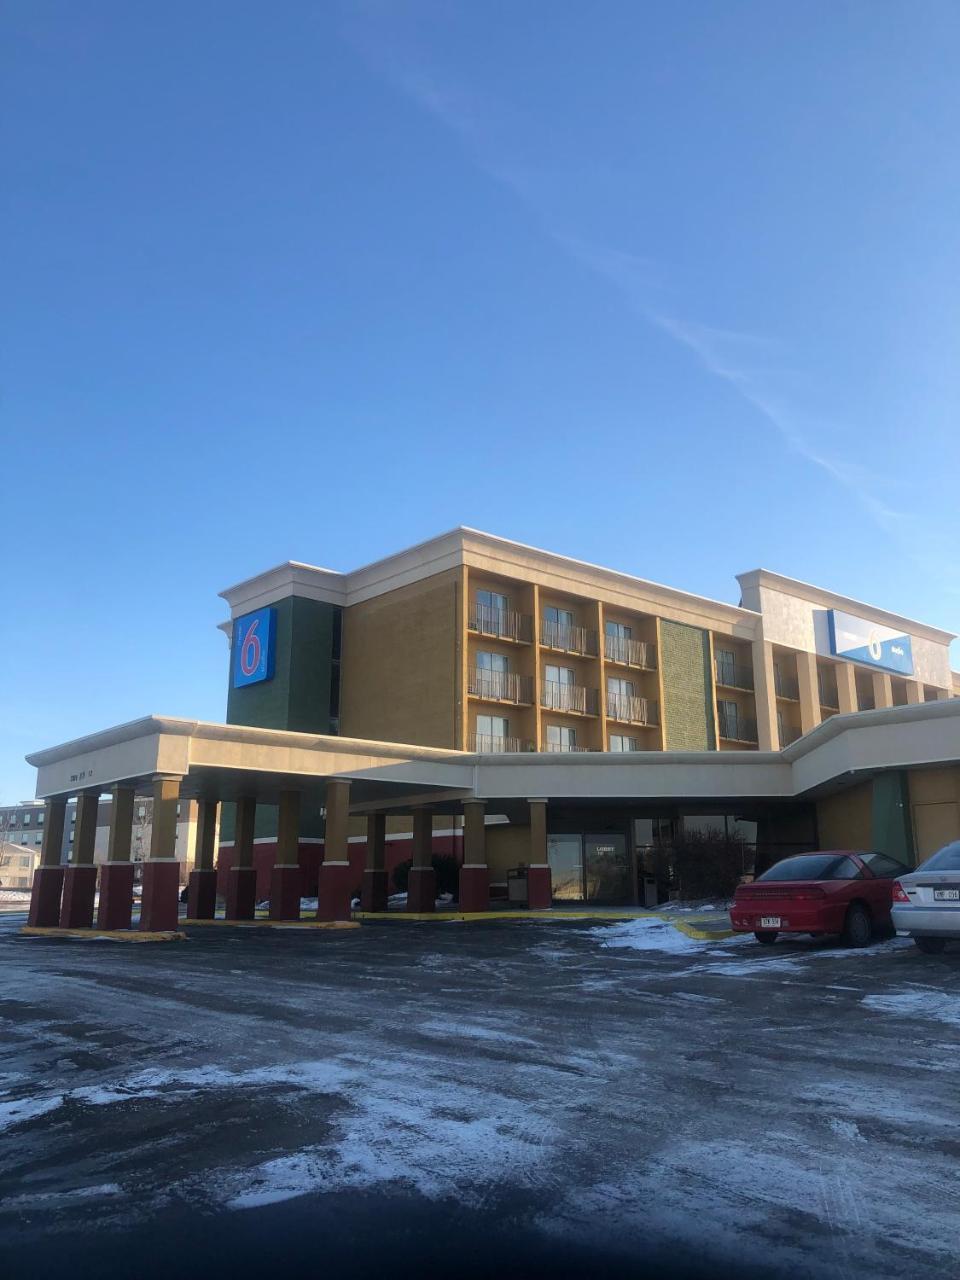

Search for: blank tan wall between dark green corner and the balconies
xmin=340 ymin=570 xmax=463 ymax=748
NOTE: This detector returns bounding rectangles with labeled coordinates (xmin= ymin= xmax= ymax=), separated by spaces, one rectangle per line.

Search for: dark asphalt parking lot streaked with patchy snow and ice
xmin=0 ymin=916 xmax=960 ymax=1277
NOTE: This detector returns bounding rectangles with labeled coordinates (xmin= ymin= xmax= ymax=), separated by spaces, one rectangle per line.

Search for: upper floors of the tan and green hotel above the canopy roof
xmin=221 ymin=529 xmax=956 ymax=753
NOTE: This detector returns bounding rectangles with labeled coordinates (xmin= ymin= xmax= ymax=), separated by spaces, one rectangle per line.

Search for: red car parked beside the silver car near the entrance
xmin=730 ymin=849 xmax=909 ymax=947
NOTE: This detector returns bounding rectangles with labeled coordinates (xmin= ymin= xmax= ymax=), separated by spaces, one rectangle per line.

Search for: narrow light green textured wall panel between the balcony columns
xmin=660 ymin=620 xmax=717 ymax=751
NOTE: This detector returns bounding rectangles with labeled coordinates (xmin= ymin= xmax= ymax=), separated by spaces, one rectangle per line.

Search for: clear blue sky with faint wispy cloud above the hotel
xmin=0 ymin=0 xmax=960 ymax=800
